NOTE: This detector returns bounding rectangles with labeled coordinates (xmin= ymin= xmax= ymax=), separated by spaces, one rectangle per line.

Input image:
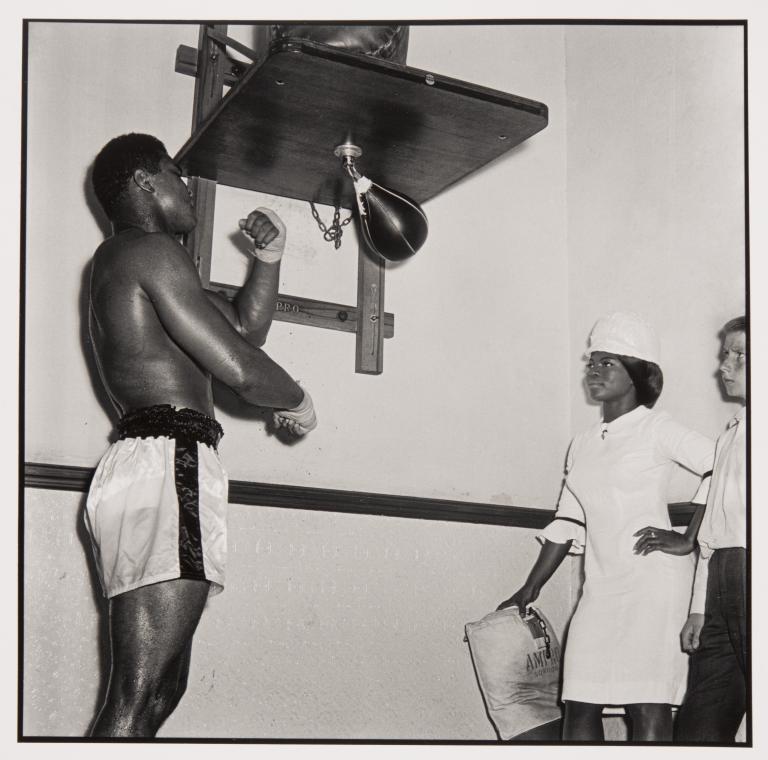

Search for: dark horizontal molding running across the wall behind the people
xmin=24 ymin=462 xmax=695 ymax=528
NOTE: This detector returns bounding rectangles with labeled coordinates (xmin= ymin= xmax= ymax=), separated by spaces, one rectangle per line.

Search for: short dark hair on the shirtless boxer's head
xmin=91 ymin=132 xmax=168 ymax=220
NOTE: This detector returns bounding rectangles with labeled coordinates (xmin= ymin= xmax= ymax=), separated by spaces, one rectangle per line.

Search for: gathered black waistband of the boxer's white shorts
xmin=117 ymin=404 xmax=224 ymax=449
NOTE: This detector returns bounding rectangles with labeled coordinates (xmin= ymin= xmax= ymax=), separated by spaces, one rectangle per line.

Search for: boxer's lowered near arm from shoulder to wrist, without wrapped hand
xmin=138 ymin=233 xmax=304 ymax=409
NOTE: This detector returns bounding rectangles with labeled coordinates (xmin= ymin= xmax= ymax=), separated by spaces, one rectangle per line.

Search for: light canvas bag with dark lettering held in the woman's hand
xmin=464 ymin=607 xmax=561 ymax=740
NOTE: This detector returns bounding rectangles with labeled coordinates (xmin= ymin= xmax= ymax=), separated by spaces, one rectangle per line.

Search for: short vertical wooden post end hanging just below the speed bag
xmin=355 ymin=244 xmax=386 ymax=375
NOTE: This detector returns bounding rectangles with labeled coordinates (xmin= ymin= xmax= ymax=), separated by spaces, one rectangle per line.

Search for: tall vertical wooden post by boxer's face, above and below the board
xmin=186 ymin=24 xmax=230 ymax=287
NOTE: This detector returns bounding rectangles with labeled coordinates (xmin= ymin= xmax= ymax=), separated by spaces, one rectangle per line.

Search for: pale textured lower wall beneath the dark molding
xmin=24 ymin=489 xmax=571 ymax=739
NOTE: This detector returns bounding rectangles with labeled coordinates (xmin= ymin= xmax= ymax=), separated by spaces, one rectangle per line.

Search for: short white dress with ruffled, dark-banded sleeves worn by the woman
xmin=538 ymin=406 xmax=715 ymax=705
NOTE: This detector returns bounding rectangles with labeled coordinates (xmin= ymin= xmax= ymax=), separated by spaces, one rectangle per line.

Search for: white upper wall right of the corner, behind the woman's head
xmin=566 ymin=26 xmax=745 ymax=464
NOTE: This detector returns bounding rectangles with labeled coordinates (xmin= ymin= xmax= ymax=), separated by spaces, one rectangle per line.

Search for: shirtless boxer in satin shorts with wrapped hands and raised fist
xmin=85 ymin=134 xmax=316 ymax=737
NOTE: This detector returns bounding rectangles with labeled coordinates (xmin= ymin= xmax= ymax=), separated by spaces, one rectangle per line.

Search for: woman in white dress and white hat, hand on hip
xmin=499 ymin=312 xmax=714 ymax=741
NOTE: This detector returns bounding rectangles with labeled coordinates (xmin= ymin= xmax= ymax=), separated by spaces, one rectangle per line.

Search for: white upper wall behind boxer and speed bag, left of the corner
xmin=26 ymin=24 xmax=569 ymax=506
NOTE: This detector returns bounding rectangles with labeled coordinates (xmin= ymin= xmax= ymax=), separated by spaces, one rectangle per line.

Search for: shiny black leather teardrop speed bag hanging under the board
xmin=355 ymin=177 xmax=429 ymax=261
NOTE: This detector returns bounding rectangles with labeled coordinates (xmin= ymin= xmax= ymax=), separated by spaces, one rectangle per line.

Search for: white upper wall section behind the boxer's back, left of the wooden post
xmin=24 ymin=23 xmax=197 ymax=465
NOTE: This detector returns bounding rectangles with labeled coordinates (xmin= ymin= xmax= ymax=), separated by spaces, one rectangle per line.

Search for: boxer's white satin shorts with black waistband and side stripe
xmin=85 ymin=405 xmax=228 ymax=598
